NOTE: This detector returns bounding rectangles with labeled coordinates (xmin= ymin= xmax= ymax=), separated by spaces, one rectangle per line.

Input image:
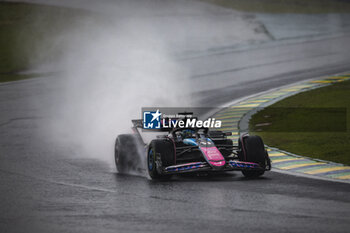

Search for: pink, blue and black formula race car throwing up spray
xmin=115 ymin=114 xmax=271 ymax=179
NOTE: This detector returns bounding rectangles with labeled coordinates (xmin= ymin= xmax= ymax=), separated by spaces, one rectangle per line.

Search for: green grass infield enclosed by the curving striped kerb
xmin=250 ymin=81 xmax=350 ymax=165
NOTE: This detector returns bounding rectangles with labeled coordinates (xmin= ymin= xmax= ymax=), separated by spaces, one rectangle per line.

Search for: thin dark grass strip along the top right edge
xmin=201 ymin=0 xmax=350 ymax=14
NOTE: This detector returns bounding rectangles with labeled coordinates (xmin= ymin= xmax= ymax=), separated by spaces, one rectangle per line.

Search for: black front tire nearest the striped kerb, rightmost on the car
xmin=238 ymin=136 xmax=268 ymax=178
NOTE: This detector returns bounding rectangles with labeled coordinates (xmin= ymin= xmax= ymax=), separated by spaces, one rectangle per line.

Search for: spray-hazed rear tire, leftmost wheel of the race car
xmin=114 ymin=134 xmax=143 ymax=173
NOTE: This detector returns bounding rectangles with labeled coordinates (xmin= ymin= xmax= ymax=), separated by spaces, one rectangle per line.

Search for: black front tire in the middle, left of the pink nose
xmin=147 ymin=139 xmax=175 ymax=180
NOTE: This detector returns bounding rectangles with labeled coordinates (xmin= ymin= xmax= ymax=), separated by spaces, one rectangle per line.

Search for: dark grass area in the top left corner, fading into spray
xmin=0 ymin=3 xmax=87 ymax=82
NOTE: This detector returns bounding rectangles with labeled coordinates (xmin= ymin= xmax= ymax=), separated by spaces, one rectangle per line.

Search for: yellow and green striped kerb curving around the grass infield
xmin=213 ymin=74 xmax=350 ymax=183
